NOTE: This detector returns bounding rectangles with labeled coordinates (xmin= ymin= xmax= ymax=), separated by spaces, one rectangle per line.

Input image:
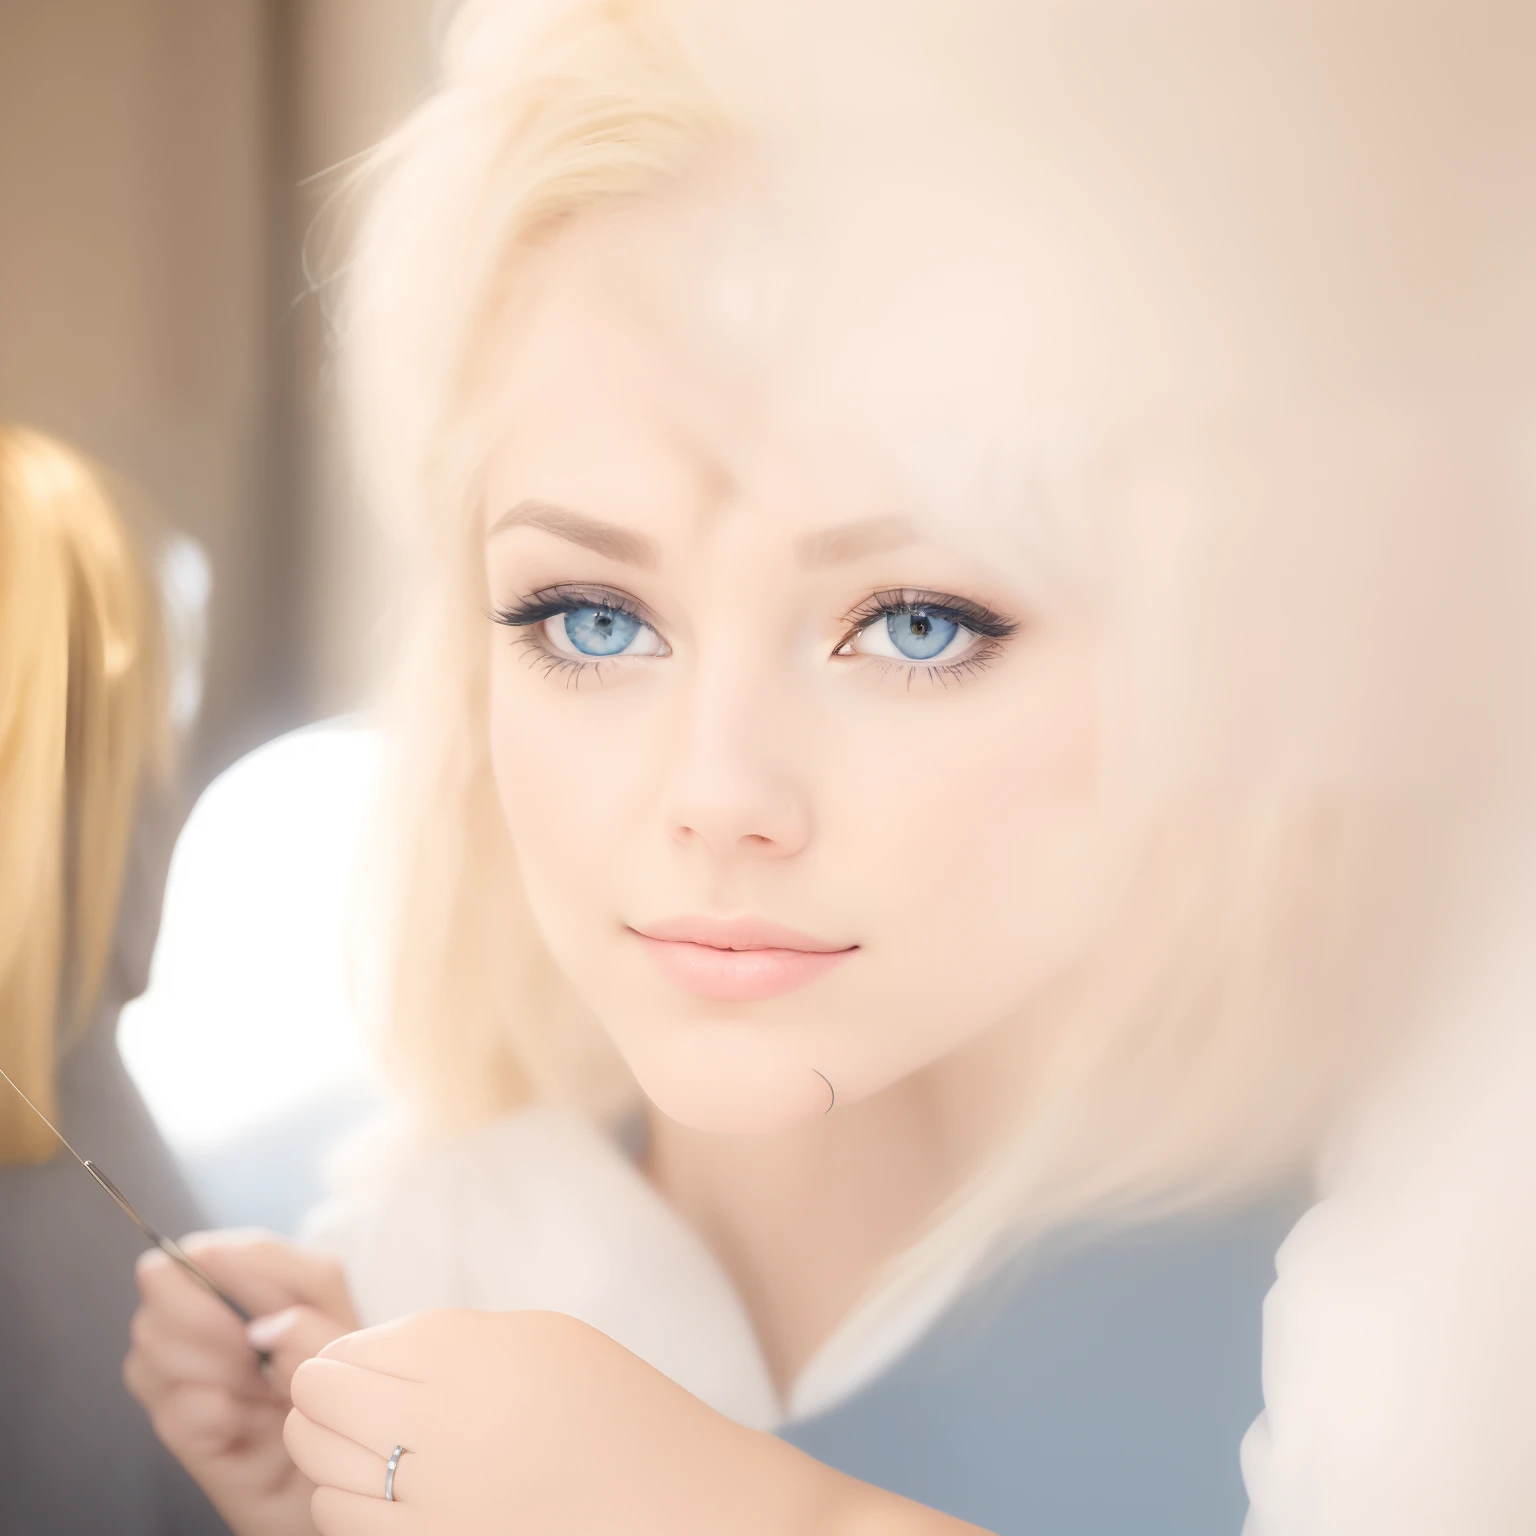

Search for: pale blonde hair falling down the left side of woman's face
xmin=339 ymin=0 xmax=727 ymax=1124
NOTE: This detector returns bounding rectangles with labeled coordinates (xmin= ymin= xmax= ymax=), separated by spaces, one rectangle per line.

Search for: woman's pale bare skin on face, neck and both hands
xmin=124 ymin=207 xmax=1120 ymax=1536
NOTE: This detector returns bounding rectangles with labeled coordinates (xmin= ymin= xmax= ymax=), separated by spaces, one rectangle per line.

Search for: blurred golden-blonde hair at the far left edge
xmin=0 ymin=424 xmax=169 ymax=1163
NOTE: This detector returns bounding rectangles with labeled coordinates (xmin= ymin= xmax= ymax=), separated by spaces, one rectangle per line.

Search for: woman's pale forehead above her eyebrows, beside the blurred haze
xmin=485 ymin=206 xmax=908 ymax=536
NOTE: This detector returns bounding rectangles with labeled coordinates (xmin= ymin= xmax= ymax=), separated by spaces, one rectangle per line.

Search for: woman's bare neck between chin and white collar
xmin=647 ymin=1040 xmax=1009 ymax=1393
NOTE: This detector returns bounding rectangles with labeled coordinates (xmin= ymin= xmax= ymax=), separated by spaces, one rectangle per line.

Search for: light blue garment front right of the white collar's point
xmin=785 ymin=1195 xmax=1306 ymax=1536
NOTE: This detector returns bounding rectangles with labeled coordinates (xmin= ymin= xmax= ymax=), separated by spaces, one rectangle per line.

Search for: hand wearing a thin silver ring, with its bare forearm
xmin=286 ymin=1312 xmax=975 ymax=1536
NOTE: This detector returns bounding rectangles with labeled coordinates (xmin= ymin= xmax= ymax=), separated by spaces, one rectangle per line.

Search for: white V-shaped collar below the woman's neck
xmin=306 ymin=1106 xmax=965 ymax=1430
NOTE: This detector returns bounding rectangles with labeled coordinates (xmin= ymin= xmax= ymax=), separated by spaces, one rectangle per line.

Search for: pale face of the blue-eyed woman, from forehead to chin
xmin=484 ymin=210 xmax=1114 ymax=1132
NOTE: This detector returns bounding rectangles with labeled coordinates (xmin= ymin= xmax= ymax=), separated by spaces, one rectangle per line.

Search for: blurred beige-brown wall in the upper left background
xmin=0 ymin=0 xmax=435 ymax=776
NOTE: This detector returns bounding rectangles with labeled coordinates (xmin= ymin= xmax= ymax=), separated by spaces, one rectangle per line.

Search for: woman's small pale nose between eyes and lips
xmin=664 ymin=663 xmax=813 ymax=859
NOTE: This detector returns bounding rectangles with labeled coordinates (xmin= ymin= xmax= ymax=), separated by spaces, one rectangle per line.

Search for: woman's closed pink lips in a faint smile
xmin=631 ymin=917 xmax=859 ymax=1003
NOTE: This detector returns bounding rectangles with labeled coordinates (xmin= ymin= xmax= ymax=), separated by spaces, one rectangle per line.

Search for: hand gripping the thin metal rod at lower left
xmin=123 ymin=1232 xmax=356 ymax=1536
